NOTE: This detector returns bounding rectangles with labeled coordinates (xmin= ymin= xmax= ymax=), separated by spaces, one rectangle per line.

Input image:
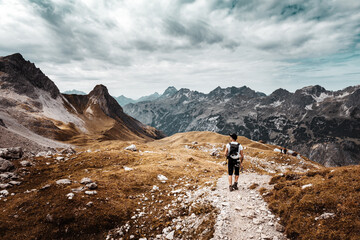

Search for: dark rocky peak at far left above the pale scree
xmin=0 ymin=53 xmax=60 ymax=99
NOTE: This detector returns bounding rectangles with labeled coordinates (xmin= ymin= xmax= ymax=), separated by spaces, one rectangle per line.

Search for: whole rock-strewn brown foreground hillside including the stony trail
xmin=0 ymin=132 xmax=360 ymax=239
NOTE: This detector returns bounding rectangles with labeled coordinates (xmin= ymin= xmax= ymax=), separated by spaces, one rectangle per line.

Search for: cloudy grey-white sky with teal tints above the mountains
xmin=0 ymin=0 xmax=360 ymax=98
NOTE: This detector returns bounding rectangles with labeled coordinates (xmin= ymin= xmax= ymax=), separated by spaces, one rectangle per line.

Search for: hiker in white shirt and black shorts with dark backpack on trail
xmin=225 ymin=133 xmax=244 ymax=192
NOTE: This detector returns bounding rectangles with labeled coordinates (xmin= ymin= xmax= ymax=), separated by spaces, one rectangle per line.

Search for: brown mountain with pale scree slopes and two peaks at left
xmin=0 ymin=54 xmax=163 ymax=147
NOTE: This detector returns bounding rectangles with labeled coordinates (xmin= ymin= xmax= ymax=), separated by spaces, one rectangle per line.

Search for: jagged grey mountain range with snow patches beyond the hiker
xmin=124 ymin=86 xmax=360 ymax=166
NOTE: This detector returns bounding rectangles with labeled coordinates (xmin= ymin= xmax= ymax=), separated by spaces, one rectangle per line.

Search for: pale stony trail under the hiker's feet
xmin=211 ymin=173 xmax=287 ymax=240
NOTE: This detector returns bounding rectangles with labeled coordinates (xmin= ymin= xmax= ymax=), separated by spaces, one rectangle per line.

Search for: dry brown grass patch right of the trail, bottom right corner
xmin=265 ymin=166 xmax=360 ymax=240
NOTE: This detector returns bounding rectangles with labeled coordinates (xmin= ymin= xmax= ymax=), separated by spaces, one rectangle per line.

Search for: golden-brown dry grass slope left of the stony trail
xmin=0 ymin=132 xmax=326 ymax=240
